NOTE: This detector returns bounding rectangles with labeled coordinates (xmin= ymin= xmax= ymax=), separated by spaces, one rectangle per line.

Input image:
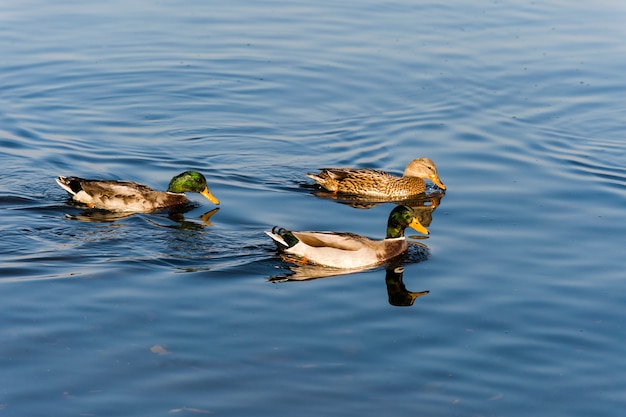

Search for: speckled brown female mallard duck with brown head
xmin=306 ymin=158 xmax=446 ymax=200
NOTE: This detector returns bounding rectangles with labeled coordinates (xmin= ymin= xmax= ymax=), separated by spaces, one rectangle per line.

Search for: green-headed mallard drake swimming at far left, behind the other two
xmin=56 ymin=171 xmax=220 ymax=213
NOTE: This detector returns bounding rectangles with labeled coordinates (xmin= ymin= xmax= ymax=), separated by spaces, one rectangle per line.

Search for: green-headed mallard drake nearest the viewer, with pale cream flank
xmin=265 ymin=206 xmax=429 ymax=269
